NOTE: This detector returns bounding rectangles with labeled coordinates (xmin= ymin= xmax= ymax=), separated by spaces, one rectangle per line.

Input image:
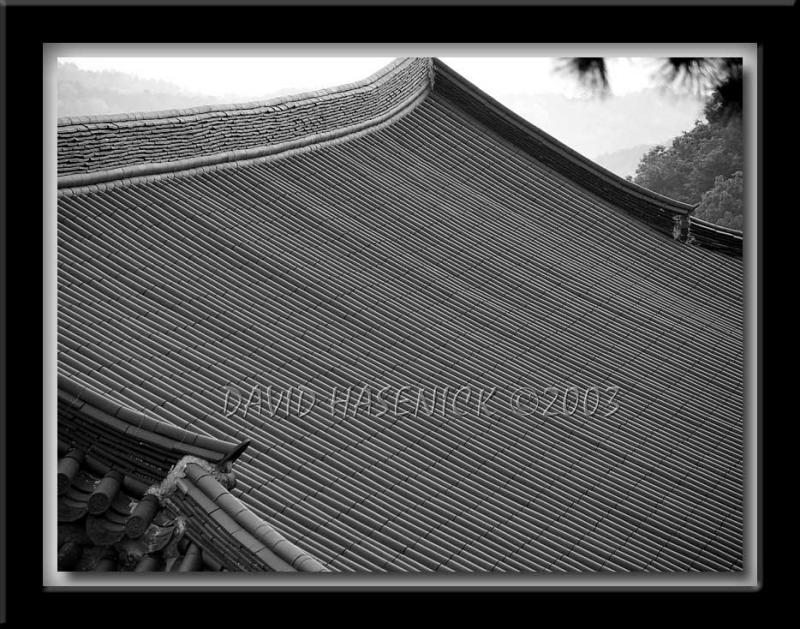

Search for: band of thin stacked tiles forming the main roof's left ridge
xmin=58 ymin=59 xmax=430 ymax=177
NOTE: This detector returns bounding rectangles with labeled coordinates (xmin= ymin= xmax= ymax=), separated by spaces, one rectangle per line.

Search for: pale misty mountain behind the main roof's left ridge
xmin=57 ymin=63 xmax=304 ymax=118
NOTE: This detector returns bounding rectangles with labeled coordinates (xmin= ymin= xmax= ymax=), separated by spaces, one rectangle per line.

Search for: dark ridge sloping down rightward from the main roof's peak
xmin=433 ymin=59 xmax=693 ymax=215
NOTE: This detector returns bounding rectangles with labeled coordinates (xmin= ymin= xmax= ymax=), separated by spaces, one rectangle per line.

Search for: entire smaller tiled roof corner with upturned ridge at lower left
xmin=57 ymin=377 xmax=326 ymax=572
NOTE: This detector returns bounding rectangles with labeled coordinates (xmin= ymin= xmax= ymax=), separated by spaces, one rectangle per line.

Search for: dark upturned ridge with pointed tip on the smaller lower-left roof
xmin=58 ymin=374 xmax=249 ymax=463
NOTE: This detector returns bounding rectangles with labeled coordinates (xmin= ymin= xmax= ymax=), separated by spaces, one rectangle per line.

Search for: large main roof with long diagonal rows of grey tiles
xmin=58 ymin=60 xmax=744 ymax=572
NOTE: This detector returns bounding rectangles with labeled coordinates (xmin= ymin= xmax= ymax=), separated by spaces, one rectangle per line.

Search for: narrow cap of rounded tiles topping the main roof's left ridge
xmin=57 ymin=57 xmax=412 ymax=127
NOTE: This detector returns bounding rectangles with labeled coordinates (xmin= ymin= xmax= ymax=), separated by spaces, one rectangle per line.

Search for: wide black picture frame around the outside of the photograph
xmin=0 ymin=0 xmax=780 ymax=623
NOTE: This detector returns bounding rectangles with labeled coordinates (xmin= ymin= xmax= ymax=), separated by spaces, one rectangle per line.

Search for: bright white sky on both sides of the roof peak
xmin=54 ymin=56 xmax=703 ymax=166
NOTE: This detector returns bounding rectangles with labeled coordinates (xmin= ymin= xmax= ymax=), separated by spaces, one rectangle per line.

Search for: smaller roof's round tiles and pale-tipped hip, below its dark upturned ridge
xmin=58 ymin=434 xmax=325 ymax=572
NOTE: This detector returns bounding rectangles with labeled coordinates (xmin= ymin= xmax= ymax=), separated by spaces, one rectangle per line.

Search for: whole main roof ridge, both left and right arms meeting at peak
xmin=57 ymin=57 xmax=742 ymax=255
